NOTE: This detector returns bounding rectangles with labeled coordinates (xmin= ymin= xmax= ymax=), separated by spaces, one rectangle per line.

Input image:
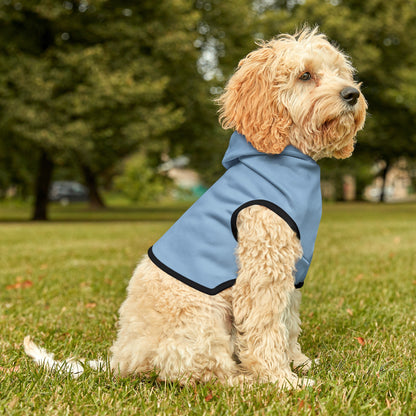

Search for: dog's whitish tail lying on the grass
xmin=23 ymin=335 xmax=107 ymax=378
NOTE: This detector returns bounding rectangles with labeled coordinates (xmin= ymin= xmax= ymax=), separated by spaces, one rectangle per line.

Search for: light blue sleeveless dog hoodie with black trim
xmin=148 ymin=132 xmax=322 ymax=295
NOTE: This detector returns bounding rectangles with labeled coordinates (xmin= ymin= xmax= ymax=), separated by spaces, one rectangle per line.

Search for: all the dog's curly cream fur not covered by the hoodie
xmin=26 ymin=29 xmax=367 ymax=387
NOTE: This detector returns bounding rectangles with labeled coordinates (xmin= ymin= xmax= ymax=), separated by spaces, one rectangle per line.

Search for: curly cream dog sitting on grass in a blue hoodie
xmin=25 ymin=28 xmax=367 ymax=388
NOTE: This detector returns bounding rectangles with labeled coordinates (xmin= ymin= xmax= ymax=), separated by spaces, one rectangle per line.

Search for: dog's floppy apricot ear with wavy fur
xmin=218 ymin=44 xmax=292 ymax=154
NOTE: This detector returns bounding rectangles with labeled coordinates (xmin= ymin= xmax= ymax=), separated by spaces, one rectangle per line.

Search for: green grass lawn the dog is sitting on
xmin=0 ymin=204 xmax=416 ymax=415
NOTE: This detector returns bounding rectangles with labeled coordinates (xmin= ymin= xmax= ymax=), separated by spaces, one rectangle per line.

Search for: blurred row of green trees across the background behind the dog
xmin=0 ymin=0 xmax=416 ymax=219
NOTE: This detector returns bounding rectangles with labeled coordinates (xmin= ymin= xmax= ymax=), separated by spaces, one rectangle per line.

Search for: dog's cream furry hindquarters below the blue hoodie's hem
xmin=111 ymin=257 xmax=237 ymax=383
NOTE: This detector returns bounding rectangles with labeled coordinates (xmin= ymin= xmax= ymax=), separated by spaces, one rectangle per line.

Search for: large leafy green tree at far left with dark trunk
xmin=0 ymin=0 xmax=195 ymax=219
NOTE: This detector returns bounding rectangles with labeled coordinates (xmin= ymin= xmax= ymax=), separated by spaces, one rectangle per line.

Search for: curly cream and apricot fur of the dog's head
xmin=218 ymin=29 xmax=366 ymax=159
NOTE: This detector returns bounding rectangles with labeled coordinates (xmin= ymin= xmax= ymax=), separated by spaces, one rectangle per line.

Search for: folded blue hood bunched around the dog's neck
xmin=222 ymin=131 xmax=315 ymax=169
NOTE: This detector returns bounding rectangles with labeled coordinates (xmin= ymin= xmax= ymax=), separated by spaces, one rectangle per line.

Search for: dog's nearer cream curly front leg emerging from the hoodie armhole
xmin=233 ymin=205 xmax=309 ymax=387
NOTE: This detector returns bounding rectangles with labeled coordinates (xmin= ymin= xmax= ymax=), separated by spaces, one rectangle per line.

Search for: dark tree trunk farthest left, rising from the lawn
xmin=32 ymin=150 xmax=54 ymax=221
